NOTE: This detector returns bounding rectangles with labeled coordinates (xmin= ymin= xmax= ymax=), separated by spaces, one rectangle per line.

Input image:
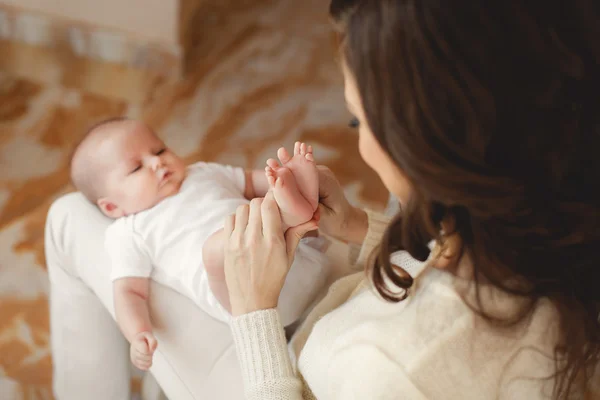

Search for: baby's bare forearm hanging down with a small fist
xmin=113 ymin=277 xmax=157 ymax=370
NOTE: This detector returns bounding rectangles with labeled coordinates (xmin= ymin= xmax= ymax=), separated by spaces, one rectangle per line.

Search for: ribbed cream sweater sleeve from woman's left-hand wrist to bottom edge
xmin=231 ymin=309 xmax=303 ymax=400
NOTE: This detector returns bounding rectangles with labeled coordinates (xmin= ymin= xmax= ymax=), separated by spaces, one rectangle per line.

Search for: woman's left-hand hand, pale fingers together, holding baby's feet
xmin=224 ymin=192 xmax=317 ymax=316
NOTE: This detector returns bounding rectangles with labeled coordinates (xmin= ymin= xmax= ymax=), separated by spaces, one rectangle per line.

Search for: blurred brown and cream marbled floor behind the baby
xmin=0 ymin=0 xmax=387 ymax=400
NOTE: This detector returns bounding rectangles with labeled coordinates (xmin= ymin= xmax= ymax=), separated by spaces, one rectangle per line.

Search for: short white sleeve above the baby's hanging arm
xmin=104 ymin=220 xmax=152 ymax=281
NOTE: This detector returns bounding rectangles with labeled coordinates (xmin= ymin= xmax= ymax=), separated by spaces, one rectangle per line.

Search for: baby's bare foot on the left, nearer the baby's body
xmin=265 ymin=159 xmax=314 ymax=230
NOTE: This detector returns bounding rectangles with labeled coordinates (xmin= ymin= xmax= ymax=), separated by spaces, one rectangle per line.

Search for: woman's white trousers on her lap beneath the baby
xmin=45 ymin=193 xmax=327 ymax=400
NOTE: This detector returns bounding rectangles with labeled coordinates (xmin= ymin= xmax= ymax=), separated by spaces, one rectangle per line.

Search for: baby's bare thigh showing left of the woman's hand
xmin=202 ymin=229 xmax=231 ymax=312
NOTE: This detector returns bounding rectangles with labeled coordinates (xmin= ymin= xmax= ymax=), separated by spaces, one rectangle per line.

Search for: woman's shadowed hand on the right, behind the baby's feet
xmin=317 ymin=165 xmax=369 ymax=244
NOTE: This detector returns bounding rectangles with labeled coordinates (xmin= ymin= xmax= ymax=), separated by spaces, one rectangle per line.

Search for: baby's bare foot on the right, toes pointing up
xmin=277 ymin=142 xmax=319 ymax=212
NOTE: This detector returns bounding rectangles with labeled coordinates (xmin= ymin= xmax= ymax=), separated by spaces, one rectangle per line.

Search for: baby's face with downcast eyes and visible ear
xmin=98 ymin=121 xmax=186 ymax=218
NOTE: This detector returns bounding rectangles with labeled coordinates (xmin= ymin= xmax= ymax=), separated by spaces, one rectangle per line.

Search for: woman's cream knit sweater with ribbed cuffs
xmin=232 ymin=214 xmax=568 ymax=400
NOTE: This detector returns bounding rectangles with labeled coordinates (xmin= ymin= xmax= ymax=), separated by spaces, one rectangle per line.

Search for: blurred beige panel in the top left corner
xmin=0 ymin=0 xmax=180 ymax=76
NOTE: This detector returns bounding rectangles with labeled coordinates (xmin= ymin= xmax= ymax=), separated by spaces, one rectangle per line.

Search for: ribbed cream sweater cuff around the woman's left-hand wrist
xmin=231 ymin=308 xmax=294 ymax=388
